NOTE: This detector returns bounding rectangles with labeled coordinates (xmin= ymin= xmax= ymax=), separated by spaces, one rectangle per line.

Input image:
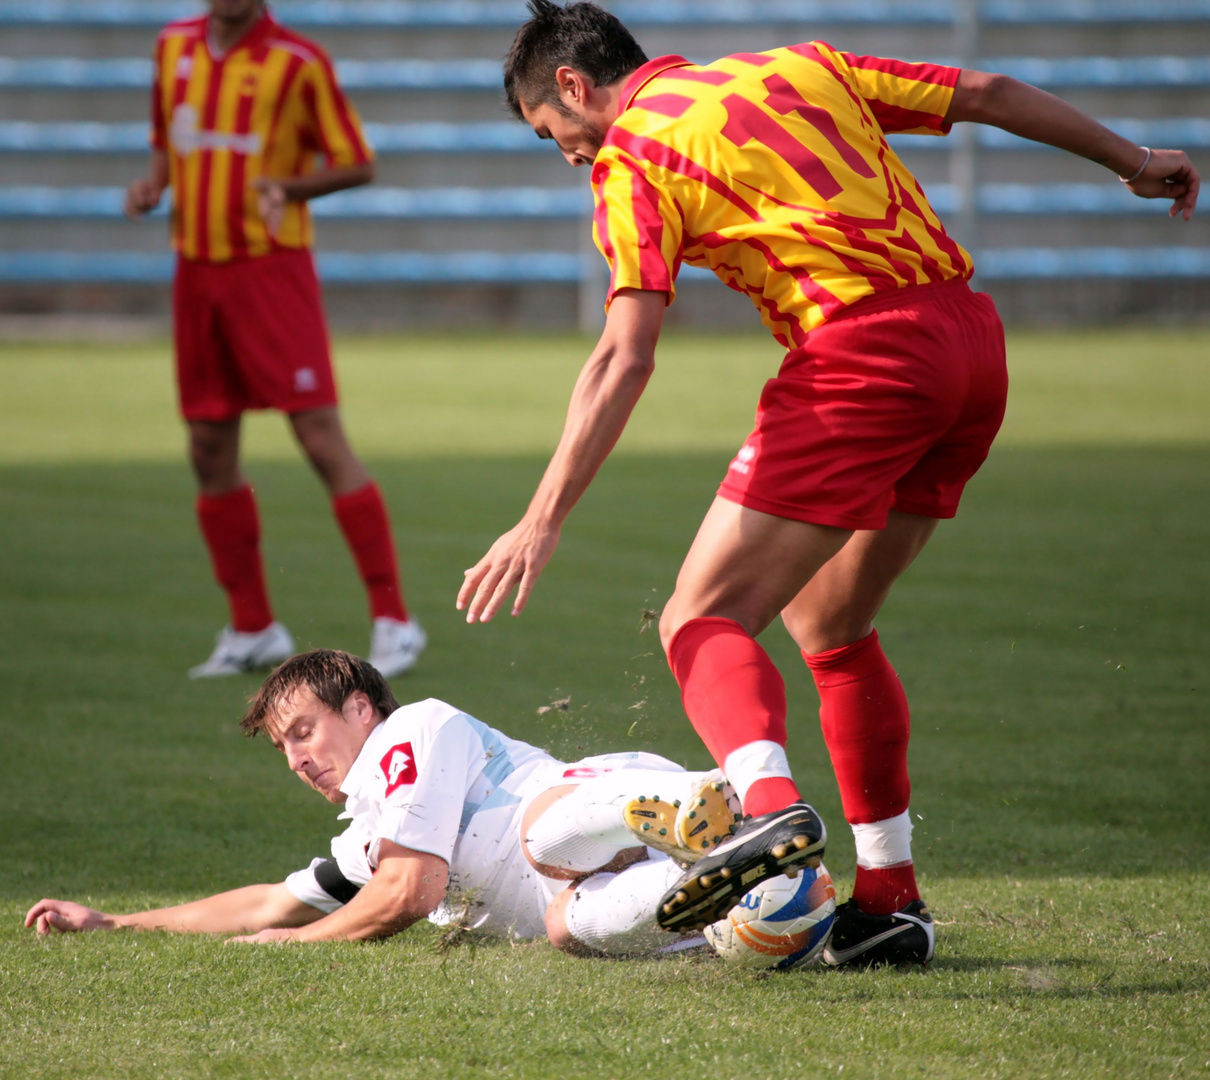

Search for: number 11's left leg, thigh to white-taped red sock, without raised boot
xmin=659 ymin=498 xmax=852 ymax=815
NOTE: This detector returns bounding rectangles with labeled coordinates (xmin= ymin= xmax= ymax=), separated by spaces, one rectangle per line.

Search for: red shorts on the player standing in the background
xmin=172 ymin=250 xmax=336 ymax=421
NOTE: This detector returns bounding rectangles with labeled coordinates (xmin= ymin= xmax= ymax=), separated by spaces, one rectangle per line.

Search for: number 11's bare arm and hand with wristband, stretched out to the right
xmin=945 ymin=69 xmax=1200 ymax=221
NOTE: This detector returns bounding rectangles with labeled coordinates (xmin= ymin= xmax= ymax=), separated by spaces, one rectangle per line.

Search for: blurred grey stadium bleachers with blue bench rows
xmin=0 ymin=0 xmax=1210 ymax=322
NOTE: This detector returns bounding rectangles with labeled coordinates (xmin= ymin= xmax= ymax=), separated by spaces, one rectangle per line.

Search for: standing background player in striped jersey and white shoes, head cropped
xmin=126 ymin=0 xmax=425 ymax=678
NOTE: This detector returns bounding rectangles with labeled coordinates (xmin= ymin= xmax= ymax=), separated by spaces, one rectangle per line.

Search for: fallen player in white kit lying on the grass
xmin=25 ymin=649 xmax=738 ymax=955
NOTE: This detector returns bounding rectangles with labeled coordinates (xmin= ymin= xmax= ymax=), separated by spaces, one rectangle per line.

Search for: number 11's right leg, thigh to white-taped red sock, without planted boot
xmin=782 ymin=512 xmax=937 ymax=914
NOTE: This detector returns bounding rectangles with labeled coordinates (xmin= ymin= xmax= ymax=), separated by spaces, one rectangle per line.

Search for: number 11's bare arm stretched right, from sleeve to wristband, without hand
xmin=946 ymin=70 xmax=1146 ymax=177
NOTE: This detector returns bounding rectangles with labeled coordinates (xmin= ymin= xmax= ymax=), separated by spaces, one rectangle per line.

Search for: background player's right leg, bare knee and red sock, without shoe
xmin=290 ymin=405 xmax=408 ymax=623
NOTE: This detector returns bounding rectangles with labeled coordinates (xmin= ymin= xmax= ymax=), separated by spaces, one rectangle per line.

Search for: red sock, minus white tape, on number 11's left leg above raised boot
xmin=668 ymin=618 xmax=801 ymax=814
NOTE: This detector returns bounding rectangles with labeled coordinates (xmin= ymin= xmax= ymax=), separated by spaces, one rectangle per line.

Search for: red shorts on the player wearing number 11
xmin=719 ymin=282 xmax=1008 ymax=529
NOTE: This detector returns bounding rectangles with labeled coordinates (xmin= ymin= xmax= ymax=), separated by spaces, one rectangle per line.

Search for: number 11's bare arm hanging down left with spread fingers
xmin=457 ymin=289 xmax=667 ymax=623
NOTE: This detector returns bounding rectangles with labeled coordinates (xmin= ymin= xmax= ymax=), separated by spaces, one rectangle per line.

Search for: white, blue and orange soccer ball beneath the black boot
xmin=703 ymin=864 xmax=836 ymax=971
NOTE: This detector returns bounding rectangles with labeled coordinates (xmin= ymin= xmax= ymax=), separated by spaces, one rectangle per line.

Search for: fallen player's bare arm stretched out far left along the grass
xmin=25 ymin=884 xmax=323 ymax=934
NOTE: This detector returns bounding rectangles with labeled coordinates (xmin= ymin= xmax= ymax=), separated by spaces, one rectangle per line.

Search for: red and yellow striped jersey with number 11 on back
xmin=593 ymin=41 xmax=972 ymax=348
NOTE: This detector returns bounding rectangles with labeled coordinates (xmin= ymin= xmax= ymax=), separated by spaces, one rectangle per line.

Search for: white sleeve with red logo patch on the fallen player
xmin=367 ymin=714 xmax=484 ymax=865
